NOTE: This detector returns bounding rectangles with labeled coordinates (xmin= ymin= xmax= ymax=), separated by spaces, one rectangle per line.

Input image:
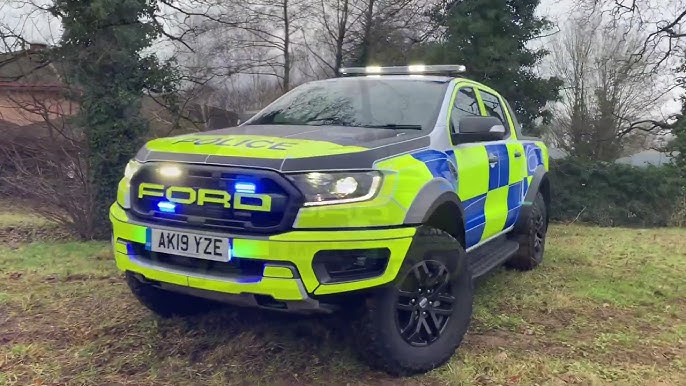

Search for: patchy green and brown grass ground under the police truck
xmin=0 ymin=210 xmax=686 ymax=385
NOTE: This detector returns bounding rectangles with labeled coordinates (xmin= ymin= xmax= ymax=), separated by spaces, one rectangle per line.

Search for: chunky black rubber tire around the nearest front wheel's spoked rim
xmin=357 ymin=226 xmax=474 ymax=376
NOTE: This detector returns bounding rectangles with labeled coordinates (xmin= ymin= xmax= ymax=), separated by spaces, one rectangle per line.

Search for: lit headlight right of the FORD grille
xmin=289 ymin=171 xmax=382 ymax=206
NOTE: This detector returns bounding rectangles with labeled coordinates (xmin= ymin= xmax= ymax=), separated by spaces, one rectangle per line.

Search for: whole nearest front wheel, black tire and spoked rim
xmin=361 ymin=227 xmax=473 ymax=376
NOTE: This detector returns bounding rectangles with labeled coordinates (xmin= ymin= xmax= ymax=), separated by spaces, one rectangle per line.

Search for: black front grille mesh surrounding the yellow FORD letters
xmin=131 ymin=163 xmax=303 ymax=234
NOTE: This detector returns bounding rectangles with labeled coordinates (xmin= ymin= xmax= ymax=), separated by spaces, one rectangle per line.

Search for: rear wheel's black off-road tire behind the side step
xmin=505 ymin=192 xmax=548 ymax=271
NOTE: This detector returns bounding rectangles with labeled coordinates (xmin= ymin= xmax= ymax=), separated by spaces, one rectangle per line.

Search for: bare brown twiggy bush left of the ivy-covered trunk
xmin=0 ymin=120 xmax=98 ymax=239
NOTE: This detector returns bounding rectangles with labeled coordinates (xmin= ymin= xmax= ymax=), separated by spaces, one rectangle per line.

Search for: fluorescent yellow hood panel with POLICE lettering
xmin=146 ymin=134 xmax=367 ymax=159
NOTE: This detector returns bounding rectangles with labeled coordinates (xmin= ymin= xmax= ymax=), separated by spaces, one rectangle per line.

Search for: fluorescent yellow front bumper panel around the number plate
xmin=110 ymin=204 xmax=415 ymax=300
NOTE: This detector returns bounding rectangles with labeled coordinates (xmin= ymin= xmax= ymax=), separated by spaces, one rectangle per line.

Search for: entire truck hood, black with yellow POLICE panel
xmin=136 ymin=125 xmax=429 ymax=171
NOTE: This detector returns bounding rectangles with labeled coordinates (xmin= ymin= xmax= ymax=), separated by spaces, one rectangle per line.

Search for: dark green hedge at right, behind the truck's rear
xmin=550 ymin=158 xmax=686 ymax=227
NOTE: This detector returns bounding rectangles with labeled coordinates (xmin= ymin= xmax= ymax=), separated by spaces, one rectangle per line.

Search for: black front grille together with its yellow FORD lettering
xmin=131 ymin=162 xmax=304 ymax=234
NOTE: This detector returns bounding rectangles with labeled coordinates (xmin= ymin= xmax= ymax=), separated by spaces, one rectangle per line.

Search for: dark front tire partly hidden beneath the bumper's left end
xmin=126 ymin=272 xmax=218 ymax=318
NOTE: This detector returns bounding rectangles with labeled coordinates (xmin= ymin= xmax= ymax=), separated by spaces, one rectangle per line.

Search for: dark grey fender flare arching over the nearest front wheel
xmin=403 ymin=178 xmax=465 ymax=230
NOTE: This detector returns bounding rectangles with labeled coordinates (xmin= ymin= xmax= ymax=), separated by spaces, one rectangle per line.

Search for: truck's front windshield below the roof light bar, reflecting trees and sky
xmin=247 ymin=78 xmax=447 ymax=130
